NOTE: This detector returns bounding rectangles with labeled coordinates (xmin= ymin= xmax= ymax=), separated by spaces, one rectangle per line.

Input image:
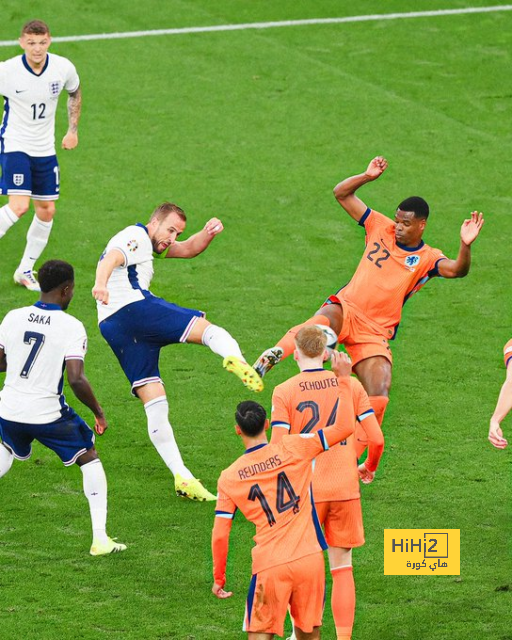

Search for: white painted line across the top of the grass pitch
xmin=0 ymin=4 xmax=512 ymax=47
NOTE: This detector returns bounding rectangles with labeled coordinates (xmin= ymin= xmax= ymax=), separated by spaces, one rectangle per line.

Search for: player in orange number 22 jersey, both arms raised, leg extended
xmin=254 ymin=156 xmax=484 ymax=438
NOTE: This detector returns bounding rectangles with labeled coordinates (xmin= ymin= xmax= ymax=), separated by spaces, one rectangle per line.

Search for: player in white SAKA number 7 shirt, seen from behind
xmin=0 ymin=260 xmax=126 ymax=556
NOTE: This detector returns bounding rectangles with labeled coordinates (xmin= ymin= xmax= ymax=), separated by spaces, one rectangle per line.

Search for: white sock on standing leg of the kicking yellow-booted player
xmin=144 ymin=396 xmax=194 ymax=480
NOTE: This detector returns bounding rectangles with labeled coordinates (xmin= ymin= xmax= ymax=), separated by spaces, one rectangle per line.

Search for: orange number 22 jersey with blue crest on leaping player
xmin=337 ymin=209 xmax=445 ymax=338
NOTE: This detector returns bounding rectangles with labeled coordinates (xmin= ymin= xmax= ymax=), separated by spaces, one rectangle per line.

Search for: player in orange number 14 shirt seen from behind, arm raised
xmin=212 ymin=353 xmax=355 ymax=640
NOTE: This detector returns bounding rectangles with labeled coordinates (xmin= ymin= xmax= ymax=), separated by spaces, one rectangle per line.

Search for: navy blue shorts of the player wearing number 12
xmin=0 ymin=151 xmax=60 ymax=200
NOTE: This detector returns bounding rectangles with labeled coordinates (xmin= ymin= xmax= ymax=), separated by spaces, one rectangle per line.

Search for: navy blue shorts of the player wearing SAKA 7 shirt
xmin=0 ymin=408 xmax=94 ymax=467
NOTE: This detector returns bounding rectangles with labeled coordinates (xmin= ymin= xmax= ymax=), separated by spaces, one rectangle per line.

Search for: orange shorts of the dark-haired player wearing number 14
xmin=243 ymin=551 xmax=325 ymax=636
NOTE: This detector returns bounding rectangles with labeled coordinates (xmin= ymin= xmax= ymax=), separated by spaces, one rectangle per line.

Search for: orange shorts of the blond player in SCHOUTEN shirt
xmin=315 ymin=498 xmax=364 ymax=549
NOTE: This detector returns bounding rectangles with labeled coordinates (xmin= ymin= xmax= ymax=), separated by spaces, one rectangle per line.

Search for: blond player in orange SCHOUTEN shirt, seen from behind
xmin=270 ymin=326 xmax=384 ymax=640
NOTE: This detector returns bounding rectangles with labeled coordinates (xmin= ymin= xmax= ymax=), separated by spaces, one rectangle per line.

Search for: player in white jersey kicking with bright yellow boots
xmin=92 ymin=202 xmax=263 ymax=501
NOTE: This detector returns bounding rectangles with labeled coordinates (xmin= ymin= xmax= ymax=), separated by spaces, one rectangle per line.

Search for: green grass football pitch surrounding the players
xmin=0 ymin=0 xmax=512 ymax=640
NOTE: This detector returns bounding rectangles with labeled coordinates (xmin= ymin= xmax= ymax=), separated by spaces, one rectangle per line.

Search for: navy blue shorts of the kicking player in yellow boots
xmin=100 ymin=296 xmax=204 ymax=395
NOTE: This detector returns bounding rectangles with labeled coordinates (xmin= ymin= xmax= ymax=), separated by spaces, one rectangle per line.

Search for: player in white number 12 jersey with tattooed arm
xmin=0 ymin=20 xmax=82 ymax=291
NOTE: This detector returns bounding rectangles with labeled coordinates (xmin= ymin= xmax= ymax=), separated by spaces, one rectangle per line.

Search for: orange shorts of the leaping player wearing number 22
xmin=322 ymin=295 xmax=393 ymax=365
